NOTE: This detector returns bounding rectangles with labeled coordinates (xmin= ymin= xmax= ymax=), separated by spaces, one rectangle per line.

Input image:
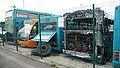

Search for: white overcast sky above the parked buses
xmin=0 ymin=0 xmax=120 ymax=21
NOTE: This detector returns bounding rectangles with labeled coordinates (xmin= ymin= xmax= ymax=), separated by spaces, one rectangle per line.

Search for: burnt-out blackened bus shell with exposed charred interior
xmin=63 ymin=8 xmax=113 ymax=63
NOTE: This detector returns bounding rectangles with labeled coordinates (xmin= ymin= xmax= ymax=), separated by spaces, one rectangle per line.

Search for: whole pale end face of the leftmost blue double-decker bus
xmin=5 ymin=10 xmax=15 ymax=44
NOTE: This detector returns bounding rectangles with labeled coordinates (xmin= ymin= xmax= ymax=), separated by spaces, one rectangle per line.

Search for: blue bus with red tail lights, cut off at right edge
xmin=113 ymin=6 xmax=120 ymax=68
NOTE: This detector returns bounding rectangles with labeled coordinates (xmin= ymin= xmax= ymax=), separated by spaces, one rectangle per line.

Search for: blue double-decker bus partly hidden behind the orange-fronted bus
xmin=5 ymin=8 xmax=56 ymax=44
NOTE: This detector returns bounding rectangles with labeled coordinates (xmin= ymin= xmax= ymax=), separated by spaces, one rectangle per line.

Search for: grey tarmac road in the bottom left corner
xmin=0 ymin=48 xmax=52 ymax=68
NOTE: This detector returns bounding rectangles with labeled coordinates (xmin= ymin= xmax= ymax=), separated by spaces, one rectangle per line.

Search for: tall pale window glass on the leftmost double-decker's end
xmin=5 ymin=10 xmax=14 ymax=34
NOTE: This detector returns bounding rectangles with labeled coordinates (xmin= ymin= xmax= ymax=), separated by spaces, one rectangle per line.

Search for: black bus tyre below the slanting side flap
xmin=37 ymin=43 xmax=51 ymax=56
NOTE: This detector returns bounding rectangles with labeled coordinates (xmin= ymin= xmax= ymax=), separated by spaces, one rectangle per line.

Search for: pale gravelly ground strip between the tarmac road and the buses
xmin=0 ymin=44 xmax=113 ymax=68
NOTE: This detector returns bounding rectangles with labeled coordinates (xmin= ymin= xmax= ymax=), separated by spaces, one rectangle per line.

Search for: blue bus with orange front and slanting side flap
xmin=18 ymin=16 xmax=64 ymax=56
